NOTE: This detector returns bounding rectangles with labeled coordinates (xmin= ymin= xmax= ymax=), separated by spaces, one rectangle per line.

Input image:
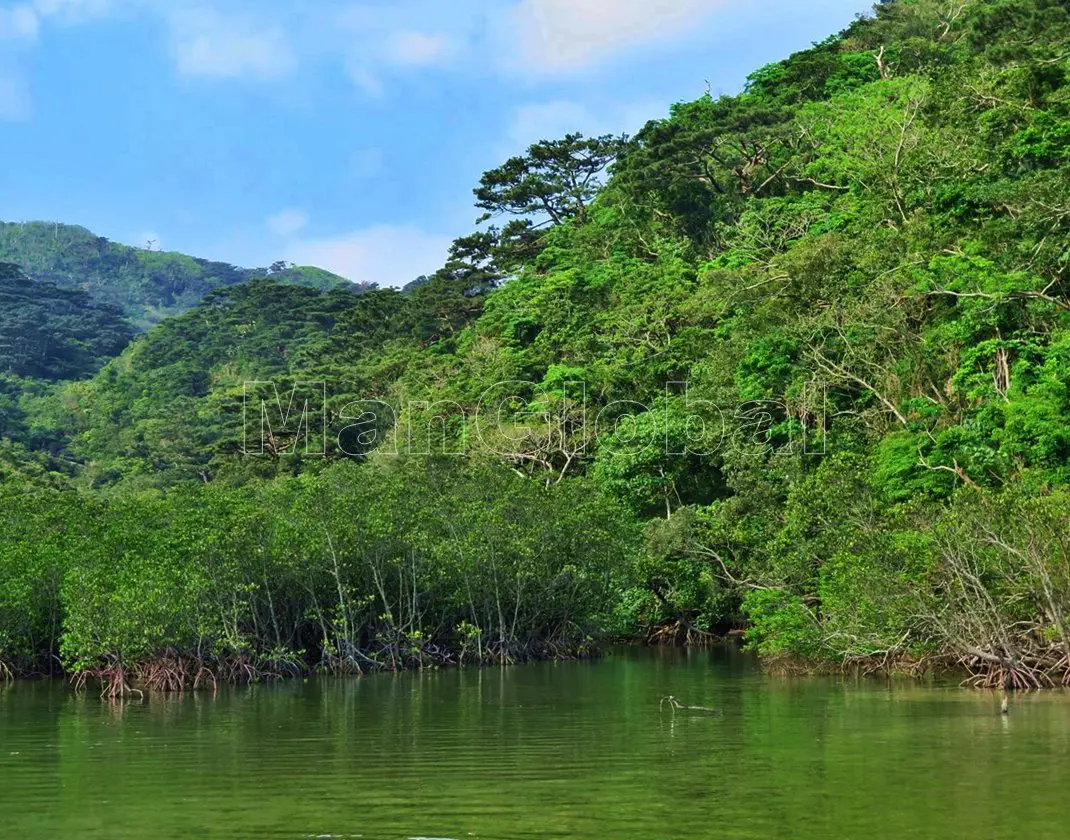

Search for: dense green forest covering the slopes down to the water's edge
xmin=0 ymin=0 xmax=1070 ymax=691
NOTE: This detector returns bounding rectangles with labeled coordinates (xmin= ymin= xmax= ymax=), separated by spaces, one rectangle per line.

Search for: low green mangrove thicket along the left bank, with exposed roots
xmin=0 ymin=462 xmax=629 ymax=673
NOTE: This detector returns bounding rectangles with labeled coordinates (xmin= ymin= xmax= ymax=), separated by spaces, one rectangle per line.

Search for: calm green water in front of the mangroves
xmin=0 ymin=651 xmax=1070 ymax=840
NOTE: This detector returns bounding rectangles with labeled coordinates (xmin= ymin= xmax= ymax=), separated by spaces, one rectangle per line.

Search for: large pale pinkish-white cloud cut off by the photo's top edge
xmin=508 ymin=0 xmax=730 ymax=73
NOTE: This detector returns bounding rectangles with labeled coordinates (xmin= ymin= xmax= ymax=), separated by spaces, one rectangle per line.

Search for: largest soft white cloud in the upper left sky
xmin=170 ymin=10 xmax=295 ymax=79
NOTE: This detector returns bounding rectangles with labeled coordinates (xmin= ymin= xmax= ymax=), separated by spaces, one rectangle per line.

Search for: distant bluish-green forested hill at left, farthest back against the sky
xmin=0 ymin=222 xmax=359 ymax=329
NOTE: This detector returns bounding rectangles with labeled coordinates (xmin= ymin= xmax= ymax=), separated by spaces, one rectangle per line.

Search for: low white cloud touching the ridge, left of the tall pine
xmin=286 ymin=225 xmax=453 ymax=287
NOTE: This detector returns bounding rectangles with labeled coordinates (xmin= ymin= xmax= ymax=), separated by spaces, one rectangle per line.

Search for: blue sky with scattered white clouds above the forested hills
xmin=0 ymin=0 xmax=871 ymax=286
